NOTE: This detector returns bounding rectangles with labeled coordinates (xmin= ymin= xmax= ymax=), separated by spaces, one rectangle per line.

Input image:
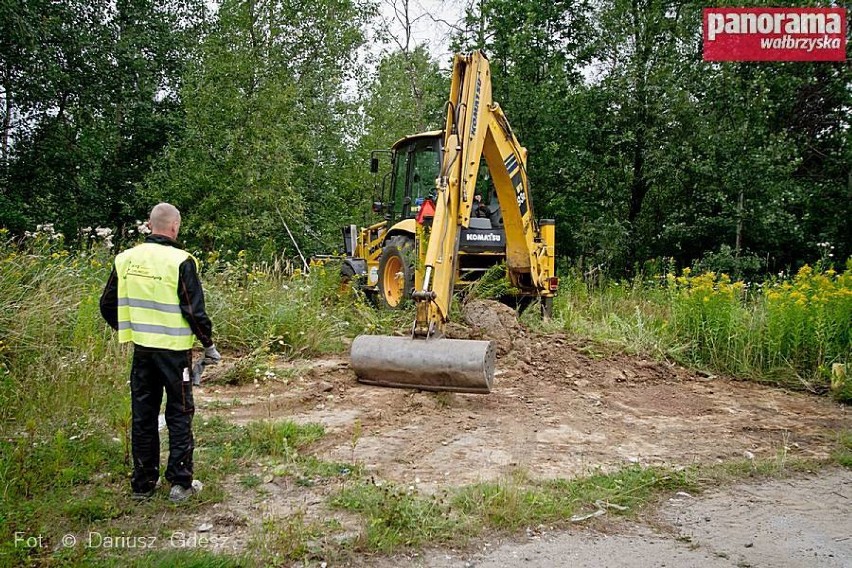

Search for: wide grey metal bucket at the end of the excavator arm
xmin=351 ymin=335 xmax=496 ymax=394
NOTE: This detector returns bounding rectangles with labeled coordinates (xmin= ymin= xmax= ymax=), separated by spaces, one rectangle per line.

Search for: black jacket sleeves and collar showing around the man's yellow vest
xmin=101 ymin=235 xmax=213 ymax=347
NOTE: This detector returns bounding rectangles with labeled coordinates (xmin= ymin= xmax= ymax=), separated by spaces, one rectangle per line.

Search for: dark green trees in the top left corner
xmin=0 ymin=0 xmax=203 ymax=237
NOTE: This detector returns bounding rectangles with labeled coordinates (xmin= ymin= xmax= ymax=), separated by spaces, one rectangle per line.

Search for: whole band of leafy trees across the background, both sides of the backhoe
xmin=0 ymin=0 xmax=852 ymax=277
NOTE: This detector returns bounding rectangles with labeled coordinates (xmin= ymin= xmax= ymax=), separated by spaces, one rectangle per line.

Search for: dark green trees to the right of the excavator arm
xmin=457 ymin=0 xmax=852 ymax=274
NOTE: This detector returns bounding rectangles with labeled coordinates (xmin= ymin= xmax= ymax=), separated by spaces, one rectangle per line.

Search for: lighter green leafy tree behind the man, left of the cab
xmin=144 ymin=0 xmax=370 ymax=253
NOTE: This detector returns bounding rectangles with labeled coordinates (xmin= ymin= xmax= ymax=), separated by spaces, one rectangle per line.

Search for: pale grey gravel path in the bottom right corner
xmin=382 ymin=470 xmax=852 ymax=568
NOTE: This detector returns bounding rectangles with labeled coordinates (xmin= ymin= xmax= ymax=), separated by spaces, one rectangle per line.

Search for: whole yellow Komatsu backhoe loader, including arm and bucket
xmin=344 ymin=51 xmax=558 ymax=393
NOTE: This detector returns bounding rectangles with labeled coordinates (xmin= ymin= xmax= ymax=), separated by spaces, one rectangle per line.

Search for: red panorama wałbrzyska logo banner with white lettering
xmin=704 ymin=8 xmax=846 ymax=61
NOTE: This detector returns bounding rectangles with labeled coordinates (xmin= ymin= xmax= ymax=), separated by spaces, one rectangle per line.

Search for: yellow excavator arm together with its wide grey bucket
xmin=351 ymin=51 xmax=557 ymax=393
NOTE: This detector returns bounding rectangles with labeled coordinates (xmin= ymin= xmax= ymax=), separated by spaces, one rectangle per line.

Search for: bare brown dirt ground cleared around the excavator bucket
xmin=190 ymin=302 xmax=852 ymax=560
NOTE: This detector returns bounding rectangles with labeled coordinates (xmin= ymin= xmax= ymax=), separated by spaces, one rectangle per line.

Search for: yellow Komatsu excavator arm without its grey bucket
xmin=412 ymin=51 xmax=557 ymax=337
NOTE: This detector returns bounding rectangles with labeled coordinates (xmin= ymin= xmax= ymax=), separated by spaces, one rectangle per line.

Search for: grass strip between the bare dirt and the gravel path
xmin=330 ymin=454 xmax=852 ymax=553
